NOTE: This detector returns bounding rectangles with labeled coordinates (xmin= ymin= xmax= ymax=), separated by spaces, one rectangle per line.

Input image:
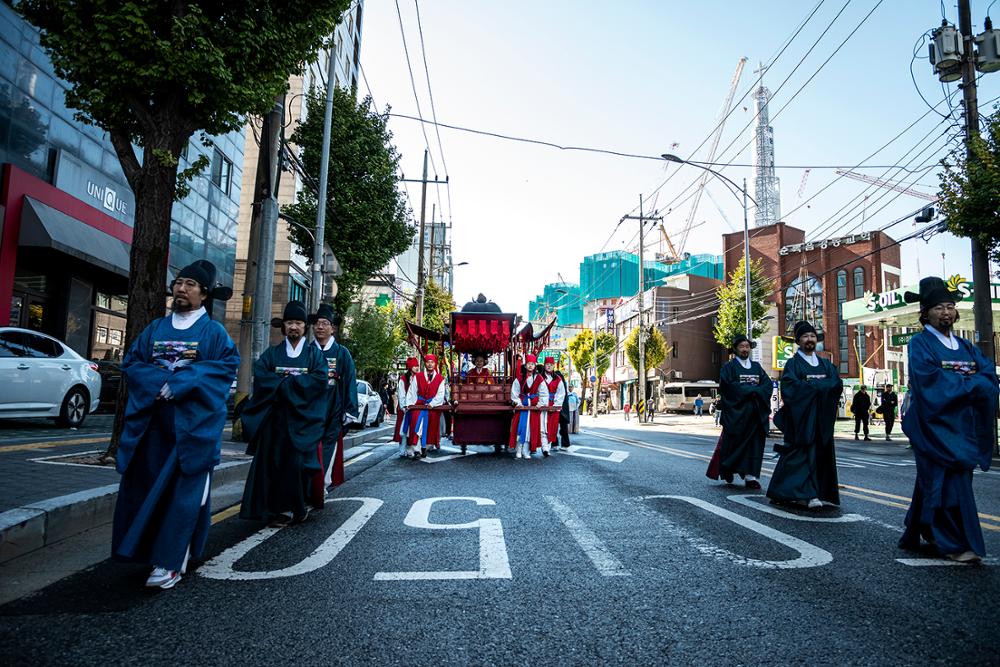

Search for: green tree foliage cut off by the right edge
xmin=938 ymin=105 xmax=1000 ymax=270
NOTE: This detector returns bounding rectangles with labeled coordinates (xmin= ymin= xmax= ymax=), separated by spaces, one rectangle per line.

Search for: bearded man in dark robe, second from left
xmin=240 ymin=301 xmax=328 ymax=527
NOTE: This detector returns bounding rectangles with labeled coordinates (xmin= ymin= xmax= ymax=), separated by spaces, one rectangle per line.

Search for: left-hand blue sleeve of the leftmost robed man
xmin=115 ymin=319 xmax=170 ymax=473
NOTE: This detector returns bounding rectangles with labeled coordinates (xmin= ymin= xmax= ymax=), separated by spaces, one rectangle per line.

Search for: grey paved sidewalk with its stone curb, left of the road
xmin=0 ymin=421 xmax=393 ymax=563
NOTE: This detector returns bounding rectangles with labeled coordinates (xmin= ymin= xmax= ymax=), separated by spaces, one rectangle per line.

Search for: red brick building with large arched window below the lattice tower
xmin=723 ymin=222 xmax=903 ymax=378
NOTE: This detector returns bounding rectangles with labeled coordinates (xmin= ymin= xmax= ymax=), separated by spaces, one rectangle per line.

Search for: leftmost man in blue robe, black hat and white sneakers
xmin=111 ymin=260 xmax=240 ymax=589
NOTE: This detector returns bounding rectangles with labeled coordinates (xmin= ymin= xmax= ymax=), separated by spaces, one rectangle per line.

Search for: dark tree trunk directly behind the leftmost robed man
xmin=102 ymin=134 xmax=190 ymax=461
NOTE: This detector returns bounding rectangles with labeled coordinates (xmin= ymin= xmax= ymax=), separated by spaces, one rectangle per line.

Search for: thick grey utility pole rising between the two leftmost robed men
xmin=236 ymin=93 xmax=285 ymax=399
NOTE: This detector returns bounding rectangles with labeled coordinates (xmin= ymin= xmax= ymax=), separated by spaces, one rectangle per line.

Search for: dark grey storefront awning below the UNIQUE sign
xmin=19 ymin=197 xmax=130 ymax=278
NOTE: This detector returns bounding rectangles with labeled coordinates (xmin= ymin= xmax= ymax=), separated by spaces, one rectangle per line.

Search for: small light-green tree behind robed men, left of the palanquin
xmin=343 ymin=304 xmax=405 ymax=387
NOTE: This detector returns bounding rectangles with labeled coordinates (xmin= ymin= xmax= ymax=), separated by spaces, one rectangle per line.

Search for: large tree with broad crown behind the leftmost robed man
xmin=14 ymin=0 xmax=350 ymax=455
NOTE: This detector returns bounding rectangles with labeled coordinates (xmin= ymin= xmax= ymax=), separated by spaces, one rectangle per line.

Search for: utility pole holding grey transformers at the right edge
xmin=958 ymin=0 xmax=996 ymax=363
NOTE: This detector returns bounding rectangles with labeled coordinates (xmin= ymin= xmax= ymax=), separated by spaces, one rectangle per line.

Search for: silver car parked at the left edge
xmin=0 ymin=327 xmax=101 ymax=428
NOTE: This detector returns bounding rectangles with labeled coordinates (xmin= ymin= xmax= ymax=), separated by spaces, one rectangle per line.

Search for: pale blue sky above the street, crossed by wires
xmin=358 ymin=0 xmax=1000 ymax=314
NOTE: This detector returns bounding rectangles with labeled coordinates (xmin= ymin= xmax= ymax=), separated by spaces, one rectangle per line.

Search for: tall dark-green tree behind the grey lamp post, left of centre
xmin=284 ymin=87 xmax=415 ymax=310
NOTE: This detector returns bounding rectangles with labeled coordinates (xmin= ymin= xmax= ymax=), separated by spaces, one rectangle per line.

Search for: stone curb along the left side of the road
xmin=0 ymin=426 xmax=392 ymax=563
